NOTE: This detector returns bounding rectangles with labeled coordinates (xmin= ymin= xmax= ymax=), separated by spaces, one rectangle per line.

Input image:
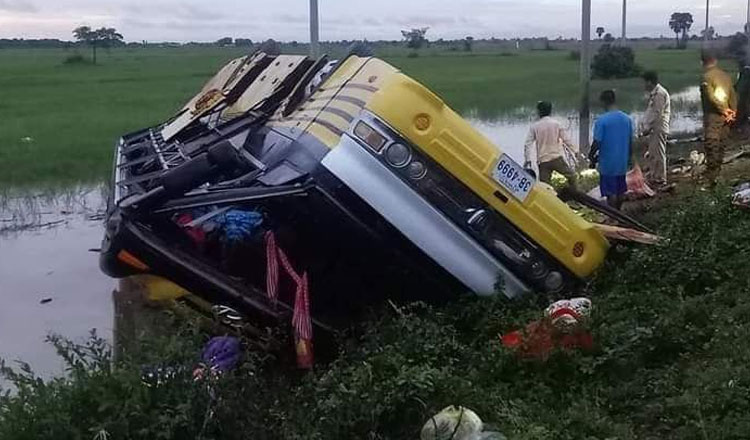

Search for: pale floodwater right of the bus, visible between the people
xmin=468 ymin=87 xmax=701 ymax=163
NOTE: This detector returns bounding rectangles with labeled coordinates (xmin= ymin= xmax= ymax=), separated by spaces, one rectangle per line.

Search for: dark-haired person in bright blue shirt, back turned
xmin=589 ymin=90 xmax=634 ymax=209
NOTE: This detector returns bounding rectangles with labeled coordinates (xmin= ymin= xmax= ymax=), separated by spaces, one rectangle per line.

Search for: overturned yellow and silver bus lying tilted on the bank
xmin=101 ymin=47 xmax=608 ymax=336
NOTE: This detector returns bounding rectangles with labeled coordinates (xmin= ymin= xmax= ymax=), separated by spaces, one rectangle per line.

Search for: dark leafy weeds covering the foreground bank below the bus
xmin=0 ymin=178 xmax=750 ymax=440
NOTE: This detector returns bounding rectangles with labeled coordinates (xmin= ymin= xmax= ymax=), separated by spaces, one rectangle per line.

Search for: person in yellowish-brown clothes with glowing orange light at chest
xmin=701 ymin=50 xmax=737 ymax=186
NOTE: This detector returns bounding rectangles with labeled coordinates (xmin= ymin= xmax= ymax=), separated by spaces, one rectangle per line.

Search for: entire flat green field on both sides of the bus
xmin=0 ymin=48 xmax=716 ymax=186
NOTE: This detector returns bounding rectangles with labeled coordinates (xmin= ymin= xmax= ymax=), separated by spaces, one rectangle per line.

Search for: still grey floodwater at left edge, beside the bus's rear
xmin=0 ymin=187 xmax=115 ymax=376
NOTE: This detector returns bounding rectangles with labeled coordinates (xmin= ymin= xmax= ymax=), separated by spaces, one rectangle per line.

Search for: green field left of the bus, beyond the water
xmin=0 ymin=49 xmax=242 ymax=185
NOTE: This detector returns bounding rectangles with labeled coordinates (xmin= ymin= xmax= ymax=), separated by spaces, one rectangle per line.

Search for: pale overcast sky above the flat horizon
xmin=0 ymin=0 xmax=747 ymax=42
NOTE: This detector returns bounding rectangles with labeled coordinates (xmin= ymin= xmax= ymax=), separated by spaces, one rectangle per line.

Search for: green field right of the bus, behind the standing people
xmin=390 ymin=51 xmax=712 ymax=119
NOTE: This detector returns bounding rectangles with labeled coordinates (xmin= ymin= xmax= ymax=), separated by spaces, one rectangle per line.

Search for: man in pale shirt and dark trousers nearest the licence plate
xmin=523 ymin=101 xmax=578 ymax=189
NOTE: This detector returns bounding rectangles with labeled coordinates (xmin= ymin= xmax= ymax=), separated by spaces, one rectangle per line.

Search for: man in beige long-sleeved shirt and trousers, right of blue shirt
xmin=639 ymin=72 xmax=672 ymax=187
